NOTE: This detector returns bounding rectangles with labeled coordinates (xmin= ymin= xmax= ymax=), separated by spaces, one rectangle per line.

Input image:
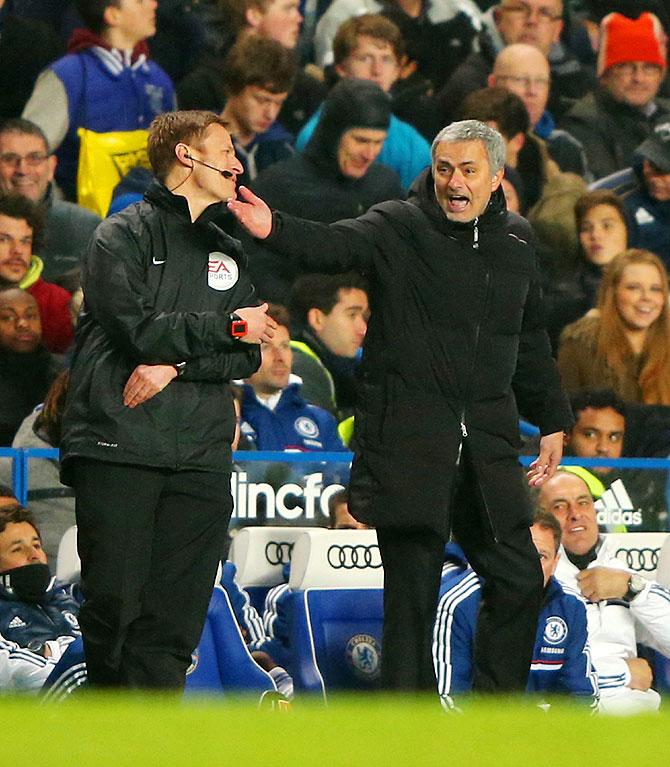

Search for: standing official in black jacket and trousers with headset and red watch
xmin=61 ymin=111 xmax=276 ymax=689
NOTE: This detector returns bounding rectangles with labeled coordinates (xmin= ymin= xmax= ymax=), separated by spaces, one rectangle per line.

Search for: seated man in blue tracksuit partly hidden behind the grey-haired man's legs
xmin=433 ymin=511 xmax=598 ymax=707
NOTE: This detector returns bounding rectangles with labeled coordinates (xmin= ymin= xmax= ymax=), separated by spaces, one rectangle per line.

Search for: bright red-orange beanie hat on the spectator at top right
xmin=598 ymin=13 xmax=667 ymax=77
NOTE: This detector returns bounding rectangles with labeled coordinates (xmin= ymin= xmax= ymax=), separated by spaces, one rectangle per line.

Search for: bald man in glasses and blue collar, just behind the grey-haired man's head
xmin=487 ymin=43 xmax=591 ymax=179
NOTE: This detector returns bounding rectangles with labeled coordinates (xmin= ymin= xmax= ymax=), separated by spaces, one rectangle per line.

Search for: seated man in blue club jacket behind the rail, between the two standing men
xmin=241 ymin=304 xmax=345 ymax=452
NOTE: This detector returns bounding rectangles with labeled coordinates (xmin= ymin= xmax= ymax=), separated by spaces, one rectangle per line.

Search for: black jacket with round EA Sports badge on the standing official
xmin=61 ymin=181 xmax=260 ymax=484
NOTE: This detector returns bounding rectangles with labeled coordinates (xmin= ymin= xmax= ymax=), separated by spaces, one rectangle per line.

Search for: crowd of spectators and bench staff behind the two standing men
xmin=0 ymin=0 xmax=670 ymax=709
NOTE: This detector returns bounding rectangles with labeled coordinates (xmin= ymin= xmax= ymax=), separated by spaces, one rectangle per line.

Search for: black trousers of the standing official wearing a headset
xmin=73 ymin=459 xmax=232 ymax=690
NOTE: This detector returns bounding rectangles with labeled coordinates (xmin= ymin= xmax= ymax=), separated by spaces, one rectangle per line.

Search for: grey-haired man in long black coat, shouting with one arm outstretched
xmin=228 ymin=120 xmax=572 ymax=692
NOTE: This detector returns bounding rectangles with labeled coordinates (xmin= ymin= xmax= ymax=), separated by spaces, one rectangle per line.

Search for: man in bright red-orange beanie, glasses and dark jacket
xmin=561 ymin=13 xmax=670 ymax=178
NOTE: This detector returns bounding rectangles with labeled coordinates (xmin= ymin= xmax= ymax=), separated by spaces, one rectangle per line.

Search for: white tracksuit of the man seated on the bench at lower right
xmin=555 ymin=538 xmax=670 ymax=713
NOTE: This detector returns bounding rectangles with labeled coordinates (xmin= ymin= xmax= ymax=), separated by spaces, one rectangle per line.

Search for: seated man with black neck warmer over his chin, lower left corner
xmin=0 ymin=504 xmax=85 ymax=693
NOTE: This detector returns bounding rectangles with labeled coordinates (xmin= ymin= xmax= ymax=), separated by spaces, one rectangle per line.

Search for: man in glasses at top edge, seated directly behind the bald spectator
xmin=437 ymin=0 xmax=595 ymax=124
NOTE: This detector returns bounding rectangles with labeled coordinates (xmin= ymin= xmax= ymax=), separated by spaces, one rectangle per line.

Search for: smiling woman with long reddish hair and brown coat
xmin=558 ymin=249 xmax=670 ymax=405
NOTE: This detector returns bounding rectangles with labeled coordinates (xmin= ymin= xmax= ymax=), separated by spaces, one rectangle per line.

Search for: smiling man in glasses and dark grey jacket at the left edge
xmin=0 ymin=118 xmax=100 ymax=290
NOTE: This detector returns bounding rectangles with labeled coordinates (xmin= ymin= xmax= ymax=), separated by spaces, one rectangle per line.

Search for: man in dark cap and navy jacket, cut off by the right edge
xmin=624 ymin=117 xmax=670 ymax=268
